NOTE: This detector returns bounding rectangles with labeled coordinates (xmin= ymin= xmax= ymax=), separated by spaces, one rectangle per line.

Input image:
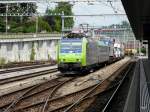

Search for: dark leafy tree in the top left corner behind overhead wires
xmin=0 ymin=3 xmax=37 ymax=32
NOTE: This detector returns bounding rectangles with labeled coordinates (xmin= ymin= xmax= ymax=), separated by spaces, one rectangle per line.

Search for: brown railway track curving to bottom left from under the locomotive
xmin=0 ymin=77 xmax=74 ymax=112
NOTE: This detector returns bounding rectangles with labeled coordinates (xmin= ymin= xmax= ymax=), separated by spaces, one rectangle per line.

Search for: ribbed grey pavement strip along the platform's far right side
xmin=140 ymin=59 xmax=150 ymax=112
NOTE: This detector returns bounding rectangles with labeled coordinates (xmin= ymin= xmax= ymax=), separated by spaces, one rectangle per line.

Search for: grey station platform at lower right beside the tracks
xmin=123 ymin=57 xmax=150 ymax=112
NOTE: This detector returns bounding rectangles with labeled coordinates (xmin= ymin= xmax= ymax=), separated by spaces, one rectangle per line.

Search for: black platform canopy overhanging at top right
xmin=121 ymin=0 xmax=150 ymax=40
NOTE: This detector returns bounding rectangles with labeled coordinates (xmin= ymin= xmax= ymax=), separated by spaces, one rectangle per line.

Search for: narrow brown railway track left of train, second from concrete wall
xmin=0 ymin=68 xmax=58 ymax=85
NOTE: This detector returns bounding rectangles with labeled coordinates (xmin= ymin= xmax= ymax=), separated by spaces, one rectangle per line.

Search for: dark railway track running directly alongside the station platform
xmin=61 ymin=61 xmax=134 ymax=112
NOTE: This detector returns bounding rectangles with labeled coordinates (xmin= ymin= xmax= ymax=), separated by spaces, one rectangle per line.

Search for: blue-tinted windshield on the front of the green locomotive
xmin=60 ymin=39 xmax=82 ymax=53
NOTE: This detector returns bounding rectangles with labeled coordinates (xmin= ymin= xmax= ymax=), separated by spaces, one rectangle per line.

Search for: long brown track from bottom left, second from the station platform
xmin=5 ymin=59 xmax=131 ymax=112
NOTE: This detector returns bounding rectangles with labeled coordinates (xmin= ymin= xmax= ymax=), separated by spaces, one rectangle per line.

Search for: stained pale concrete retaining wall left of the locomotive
xmin=0 ymin=38 xmax=59 ymax=64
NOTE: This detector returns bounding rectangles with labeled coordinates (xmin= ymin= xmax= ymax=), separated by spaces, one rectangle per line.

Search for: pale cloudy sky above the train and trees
xmin=37 ymin=0 xmax=128 ymax=27
